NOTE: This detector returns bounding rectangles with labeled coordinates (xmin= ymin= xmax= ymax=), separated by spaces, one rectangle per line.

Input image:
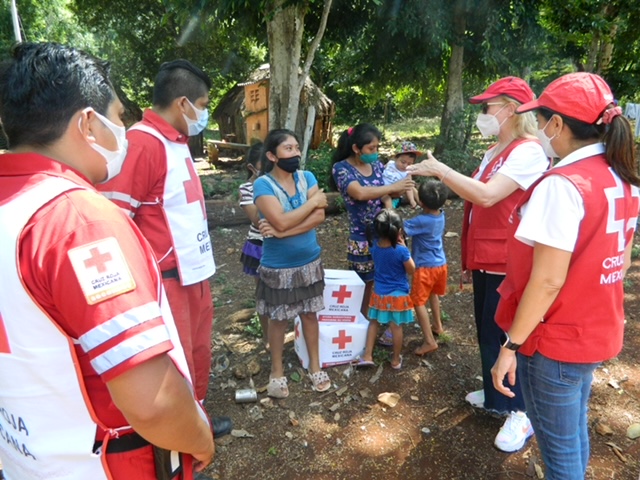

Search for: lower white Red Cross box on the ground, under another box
xmin=293 ymin=312 xmax=369 ymax=368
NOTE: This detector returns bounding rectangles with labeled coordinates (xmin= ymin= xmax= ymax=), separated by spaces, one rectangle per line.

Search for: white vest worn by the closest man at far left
xmin=0 ymin=178 xmax=107 ymax=480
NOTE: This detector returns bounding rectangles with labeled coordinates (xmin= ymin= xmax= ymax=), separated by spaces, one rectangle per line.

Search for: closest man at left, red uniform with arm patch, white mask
xmin=0 ymin=43 xmax=215 ymax=480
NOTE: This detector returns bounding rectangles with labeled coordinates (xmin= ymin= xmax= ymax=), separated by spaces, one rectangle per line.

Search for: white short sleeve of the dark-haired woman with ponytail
xmin=515 ymin=175 xmax=584 ymax=252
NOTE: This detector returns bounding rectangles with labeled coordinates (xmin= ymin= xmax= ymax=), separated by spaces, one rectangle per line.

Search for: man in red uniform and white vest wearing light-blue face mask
xmin=99 ymin=60 xmax=231 ymax=436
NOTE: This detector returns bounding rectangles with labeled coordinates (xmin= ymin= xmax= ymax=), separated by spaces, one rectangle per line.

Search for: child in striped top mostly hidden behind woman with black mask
xmin=239 ymin=142 xmax=269 ymax=351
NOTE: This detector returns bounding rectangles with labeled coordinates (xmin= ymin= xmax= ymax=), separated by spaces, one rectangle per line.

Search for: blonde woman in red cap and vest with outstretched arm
xmin=407 ymin=77 xmax=549 ymax=452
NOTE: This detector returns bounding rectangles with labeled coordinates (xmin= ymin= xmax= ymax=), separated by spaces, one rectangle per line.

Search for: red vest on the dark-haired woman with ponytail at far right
xmin=496 ymin=155 xmax=639 ymax=363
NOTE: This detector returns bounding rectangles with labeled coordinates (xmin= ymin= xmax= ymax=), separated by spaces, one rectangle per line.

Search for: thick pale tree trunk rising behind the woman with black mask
xmin=267 ymin=0 xmax=306 ymax=130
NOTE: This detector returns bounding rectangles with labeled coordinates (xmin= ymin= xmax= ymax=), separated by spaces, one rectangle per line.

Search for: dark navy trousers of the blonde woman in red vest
xmin=472 ymin=270 xmax=525 ymax=414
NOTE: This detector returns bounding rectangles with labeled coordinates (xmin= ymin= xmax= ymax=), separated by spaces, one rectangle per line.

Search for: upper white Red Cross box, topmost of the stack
xmin=318 ymin=269 xmax=364 ymax=322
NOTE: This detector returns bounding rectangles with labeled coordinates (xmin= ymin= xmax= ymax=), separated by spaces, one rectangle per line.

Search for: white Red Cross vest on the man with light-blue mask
xmin=130 ymin=123 xmax=216 ymax=285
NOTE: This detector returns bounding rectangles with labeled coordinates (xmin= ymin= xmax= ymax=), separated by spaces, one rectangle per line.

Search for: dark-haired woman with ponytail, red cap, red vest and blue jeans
xmin=492 ymin=72 xmax=640 ymax=480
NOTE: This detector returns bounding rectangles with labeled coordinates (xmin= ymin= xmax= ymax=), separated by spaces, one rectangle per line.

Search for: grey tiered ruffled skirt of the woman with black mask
xmin=256 ymin=258 xmax=324 ymax=320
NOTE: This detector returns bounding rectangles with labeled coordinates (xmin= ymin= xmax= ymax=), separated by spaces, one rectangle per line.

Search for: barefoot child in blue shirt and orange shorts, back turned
xmin=404 ymin=180 xmax=448 ymax=356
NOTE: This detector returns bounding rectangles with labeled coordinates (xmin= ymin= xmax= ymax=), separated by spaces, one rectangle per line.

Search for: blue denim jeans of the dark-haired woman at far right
xmin=517 ymin=353 xmax=599 ymax=480
